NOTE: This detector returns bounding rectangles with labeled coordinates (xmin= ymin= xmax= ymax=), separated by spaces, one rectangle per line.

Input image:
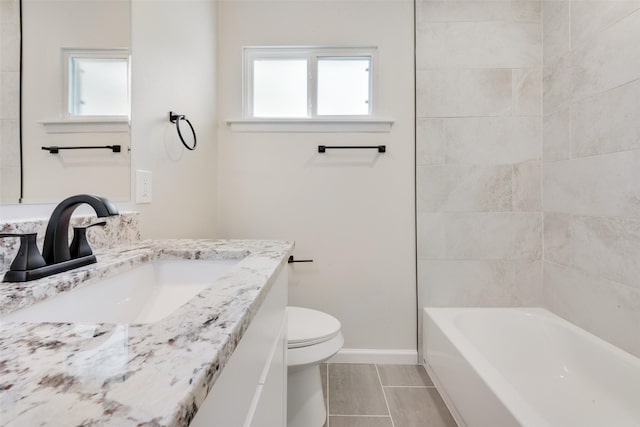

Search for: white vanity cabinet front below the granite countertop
xmin=190 ymin=269 xmax=287 ymax=427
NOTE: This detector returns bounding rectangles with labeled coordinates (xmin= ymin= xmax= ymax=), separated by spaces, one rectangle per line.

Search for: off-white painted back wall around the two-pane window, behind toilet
xmin=218 ymin=1 xmax=416 ymax=349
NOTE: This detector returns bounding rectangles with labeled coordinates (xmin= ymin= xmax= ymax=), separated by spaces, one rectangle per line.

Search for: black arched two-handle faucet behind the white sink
xmin=0 ymin=194 xmax=118 ymax=282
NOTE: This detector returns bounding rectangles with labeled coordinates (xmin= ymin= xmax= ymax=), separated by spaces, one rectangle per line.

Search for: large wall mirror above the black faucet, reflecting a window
xmin=0 ymin=0 xmax=131 ymax=204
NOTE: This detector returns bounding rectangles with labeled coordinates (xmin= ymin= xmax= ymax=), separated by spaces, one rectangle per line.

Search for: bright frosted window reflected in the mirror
xmin=63 ymin=49 xmax=130 ymax=118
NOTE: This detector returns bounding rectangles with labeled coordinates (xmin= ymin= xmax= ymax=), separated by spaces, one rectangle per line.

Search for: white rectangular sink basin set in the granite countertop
xmin=2 ymin=259 xmax=240 ymax=323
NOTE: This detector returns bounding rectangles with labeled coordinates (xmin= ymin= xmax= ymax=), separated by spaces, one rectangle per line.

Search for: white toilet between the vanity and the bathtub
xmin=287 ymin=307 xmax=344 ymax=427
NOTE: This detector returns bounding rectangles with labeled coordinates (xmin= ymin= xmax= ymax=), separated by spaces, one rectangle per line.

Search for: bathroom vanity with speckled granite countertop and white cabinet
xmin=0 ymin=240 xmax=293 ymax=427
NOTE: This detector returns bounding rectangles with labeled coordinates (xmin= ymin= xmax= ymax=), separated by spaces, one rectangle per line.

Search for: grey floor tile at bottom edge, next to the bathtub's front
xmin=384 ymin=387 xmax=456 ymax=427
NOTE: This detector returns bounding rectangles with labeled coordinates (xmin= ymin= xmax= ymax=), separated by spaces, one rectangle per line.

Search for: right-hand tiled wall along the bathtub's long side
xmin=543 ymin=0 xmax=640 ymax=356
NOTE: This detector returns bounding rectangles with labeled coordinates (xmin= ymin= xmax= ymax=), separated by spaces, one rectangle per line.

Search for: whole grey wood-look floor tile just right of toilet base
xmin=329 ymin=363 xmax=389 ymax=415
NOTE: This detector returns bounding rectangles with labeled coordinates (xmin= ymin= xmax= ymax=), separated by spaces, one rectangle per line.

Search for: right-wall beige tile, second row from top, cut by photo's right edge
xmin=573 ymin=10 xmax=640 ymax=101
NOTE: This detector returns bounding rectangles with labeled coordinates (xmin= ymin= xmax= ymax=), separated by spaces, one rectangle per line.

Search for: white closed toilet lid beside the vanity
xmin=287 ymin=307 xmax=340 ymax=348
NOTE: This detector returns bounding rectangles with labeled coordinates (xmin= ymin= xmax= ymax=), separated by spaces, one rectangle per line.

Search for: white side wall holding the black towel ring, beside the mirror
xmin=132 ymin=0 xmax=218 ymax=238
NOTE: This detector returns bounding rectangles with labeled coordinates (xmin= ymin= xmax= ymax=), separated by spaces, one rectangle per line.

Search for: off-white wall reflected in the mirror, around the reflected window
xmin=22 ymin=0 xmax=131 ymax=203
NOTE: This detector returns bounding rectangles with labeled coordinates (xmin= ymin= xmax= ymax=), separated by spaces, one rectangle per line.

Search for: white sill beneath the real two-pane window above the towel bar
xmin=226 ymin=119 xmax=393 ymax=133
